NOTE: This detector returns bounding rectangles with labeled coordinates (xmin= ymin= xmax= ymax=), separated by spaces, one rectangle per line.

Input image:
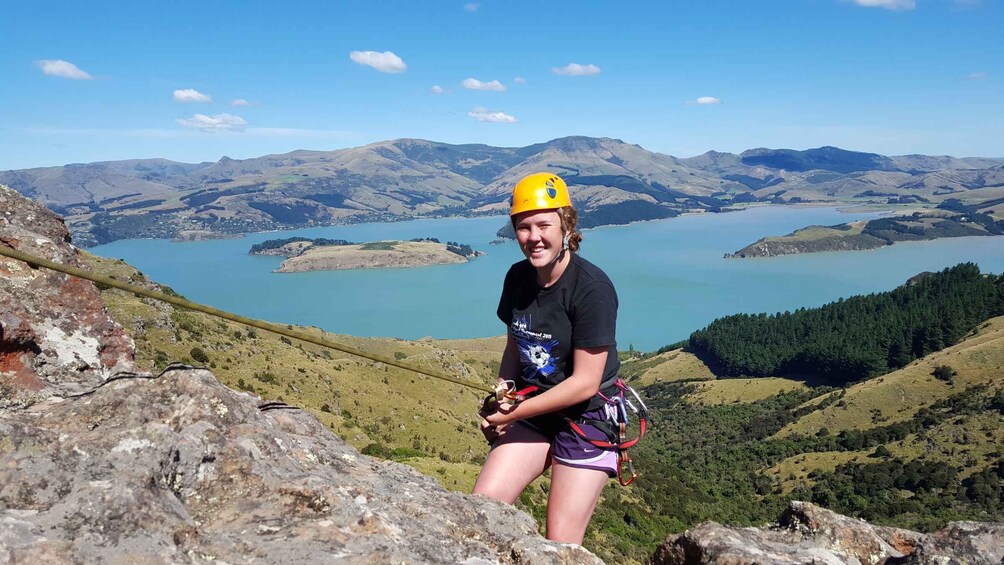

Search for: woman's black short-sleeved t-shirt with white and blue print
xmin=498 ymin=253 xmax=620 ymax=414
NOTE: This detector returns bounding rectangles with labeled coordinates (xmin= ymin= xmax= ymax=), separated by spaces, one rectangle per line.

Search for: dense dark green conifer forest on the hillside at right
xmin=688 ymin=263 xmax=1004 ymax=384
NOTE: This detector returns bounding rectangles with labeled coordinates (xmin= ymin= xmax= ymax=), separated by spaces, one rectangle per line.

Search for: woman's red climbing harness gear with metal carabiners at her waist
xmin=481 ymin=378 xmax=649 ymax=487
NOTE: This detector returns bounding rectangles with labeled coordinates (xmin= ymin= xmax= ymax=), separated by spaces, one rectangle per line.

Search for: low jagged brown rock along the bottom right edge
xmin=652 ymin=502 xmax=1004 ymax=565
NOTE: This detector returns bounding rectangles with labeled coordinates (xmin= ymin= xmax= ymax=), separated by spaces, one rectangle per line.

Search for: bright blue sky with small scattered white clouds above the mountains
xmin=0 ymin=0 xmax=1004 ymax=170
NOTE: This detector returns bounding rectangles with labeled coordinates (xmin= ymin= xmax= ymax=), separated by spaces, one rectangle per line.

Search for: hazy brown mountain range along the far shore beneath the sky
xmin=0 ymin=136 xmax=1004 ymax=246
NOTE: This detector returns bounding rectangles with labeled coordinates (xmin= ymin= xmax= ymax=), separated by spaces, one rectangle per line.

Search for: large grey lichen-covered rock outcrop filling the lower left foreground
xmin=0 ymin=190 xmax=599 ymax=564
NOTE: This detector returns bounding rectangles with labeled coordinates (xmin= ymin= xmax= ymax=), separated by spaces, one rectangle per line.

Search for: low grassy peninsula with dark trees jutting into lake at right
xmin=725 ymin=204 xmax=1004 ymax=259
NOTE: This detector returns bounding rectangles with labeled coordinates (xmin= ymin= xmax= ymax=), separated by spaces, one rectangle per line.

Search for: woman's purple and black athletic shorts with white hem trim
xmin=493 ymin=408 xmax=617 ymax=477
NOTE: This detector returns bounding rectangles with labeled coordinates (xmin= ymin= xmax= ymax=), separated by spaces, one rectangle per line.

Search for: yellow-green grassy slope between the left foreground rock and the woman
xmin=87 ymin=256 xmax=504 ymax=492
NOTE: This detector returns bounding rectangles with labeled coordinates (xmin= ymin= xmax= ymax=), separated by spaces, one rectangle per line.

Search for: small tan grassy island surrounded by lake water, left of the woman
xmin=249 ymin=237 xmax=484 ymax=273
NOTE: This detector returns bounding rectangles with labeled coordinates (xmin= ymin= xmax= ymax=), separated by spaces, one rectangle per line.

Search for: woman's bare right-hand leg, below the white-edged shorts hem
xmin=547 ymin=463 xmax=609 ymax=544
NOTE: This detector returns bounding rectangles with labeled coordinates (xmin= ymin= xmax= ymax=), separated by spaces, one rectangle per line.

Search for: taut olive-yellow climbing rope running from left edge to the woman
xmin=0 ymin=245 xmax=494 ymax=392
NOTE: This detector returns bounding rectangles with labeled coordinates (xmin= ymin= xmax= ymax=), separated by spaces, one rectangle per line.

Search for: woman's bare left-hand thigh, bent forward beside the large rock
xmin=474 ymin=422 xmax=551 ymax=504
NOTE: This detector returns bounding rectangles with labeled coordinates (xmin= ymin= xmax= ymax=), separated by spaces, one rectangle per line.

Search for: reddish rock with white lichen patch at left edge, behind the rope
xmin=0 ymin=186 xmax=135 ymax=405
